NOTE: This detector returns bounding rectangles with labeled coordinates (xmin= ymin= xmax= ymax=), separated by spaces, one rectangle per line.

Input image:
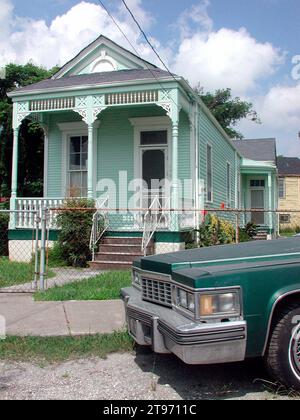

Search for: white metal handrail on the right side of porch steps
xmin=142 ymin=196 xmax=163 ymax=256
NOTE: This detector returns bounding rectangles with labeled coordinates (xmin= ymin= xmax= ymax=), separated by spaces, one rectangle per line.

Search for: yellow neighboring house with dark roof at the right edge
xmin=277 ymin=156 xmax=300 ymax=230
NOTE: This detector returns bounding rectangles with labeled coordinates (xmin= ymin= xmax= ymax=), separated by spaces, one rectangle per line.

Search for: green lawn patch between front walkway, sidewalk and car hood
xmin=35 ymin=271 xmax=131 ymax=302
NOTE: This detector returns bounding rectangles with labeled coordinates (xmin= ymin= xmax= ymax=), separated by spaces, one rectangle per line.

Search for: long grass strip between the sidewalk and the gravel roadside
xmin=0 ymin=331 xmax=134 ymax=363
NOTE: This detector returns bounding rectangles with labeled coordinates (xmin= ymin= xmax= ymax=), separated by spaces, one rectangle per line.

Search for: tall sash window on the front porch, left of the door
xmin=68 ymin=136 xmax=88 ymax=197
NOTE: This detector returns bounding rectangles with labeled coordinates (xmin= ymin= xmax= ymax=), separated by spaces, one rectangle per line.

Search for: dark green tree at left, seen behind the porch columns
xmin=0 ymin=63 xmax=57 ymax=196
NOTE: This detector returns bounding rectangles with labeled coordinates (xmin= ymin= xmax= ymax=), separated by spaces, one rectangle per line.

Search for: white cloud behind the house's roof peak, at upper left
xmin=0 ymin=0 xmax=161 ymax=67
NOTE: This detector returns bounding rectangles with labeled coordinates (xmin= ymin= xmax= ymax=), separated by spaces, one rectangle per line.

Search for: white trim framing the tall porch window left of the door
xmin=58 ymin=120 xmax=100 ymax=197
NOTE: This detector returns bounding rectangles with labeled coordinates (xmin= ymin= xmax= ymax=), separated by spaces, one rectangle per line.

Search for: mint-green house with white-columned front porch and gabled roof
xmin=10 ymin=36 xmax=278 ymax=266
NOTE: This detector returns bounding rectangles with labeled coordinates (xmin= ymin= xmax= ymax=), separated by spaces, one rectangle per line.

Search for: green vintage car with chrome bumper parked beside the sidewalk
xmin=121 ymin=238 xmax=300 ymax=389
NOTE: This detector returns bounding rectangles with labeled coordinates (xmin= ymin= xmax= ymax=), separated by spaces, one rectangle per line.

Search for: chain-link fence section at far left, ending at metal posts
xmin=0 ymin=209 xmax=44 ymax=293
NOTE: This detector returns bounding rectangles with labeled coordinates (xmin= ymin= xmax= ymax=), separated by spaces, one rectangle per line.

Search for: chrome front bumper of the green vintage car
xmin=121 ymin=287 xmax=247 ymax=365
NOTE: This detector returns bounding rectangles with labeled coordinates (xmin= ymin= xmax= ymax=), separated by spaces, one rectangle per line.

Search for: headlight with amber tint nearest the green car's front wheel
xmin=199 ymin=292 xmax=241 ymax=317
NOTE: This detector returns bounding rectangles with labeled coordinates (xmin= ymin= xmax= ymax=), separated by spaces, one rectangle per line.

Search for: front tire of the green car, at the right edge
xmin=265 ymin=303 xmax=300 ymax=391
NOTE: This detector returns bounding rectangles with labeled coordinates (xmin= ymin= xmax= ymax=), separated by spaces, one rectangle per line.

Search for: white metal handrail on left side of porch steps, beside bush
xmin=90 ymin=197 xmax=109 ymax=261
